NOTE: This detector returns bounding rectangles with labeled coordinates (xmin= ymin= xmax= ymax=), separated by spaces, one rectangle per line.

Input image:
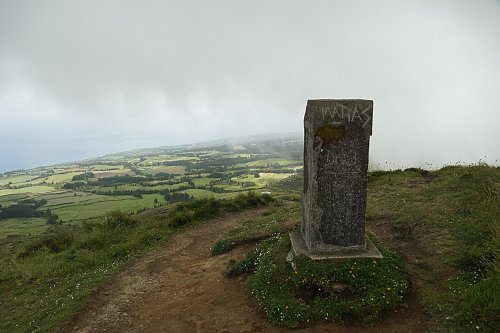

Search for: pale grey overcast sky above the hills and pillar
xmin=0 ymin=0 xmax=500 ymax=172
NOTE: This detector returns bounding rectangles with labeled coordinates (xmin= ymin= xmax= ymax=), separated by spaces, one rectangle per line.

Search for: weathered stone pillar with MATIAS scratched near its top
xmin=290 ymin=99 xmax=382 ymax=259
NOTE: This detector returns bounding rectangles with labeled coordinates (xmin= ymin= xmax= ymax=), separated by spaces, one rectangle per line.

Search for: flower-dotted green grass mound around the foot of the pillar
xmin=238 ymin=236 xmax=409 ymax=328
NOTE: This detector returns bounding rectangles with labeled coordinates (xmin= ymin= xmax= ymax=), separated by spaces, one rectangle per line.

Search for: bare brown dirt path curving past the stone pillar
xmin=64 ymin=209 xmax=422 ymax=333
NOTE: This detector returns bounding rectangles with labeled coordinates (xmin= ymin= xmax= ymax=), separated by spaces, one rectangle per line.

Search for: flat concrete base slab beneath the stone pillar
xmin=290 ymin=231 xmax=383 ymax=260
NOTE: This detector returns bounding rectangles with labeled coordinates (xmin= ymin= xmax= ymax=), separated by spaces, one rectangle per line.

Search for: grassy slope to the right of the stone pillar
xmin=368 ymin=166 xmax=500 ymax=332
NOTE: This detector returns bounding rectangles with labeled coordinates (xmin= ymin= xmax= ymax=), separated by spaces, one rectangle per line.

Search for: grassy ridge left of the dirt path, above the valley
xmin=0 ymin=193 xmax=272 ymax=332
